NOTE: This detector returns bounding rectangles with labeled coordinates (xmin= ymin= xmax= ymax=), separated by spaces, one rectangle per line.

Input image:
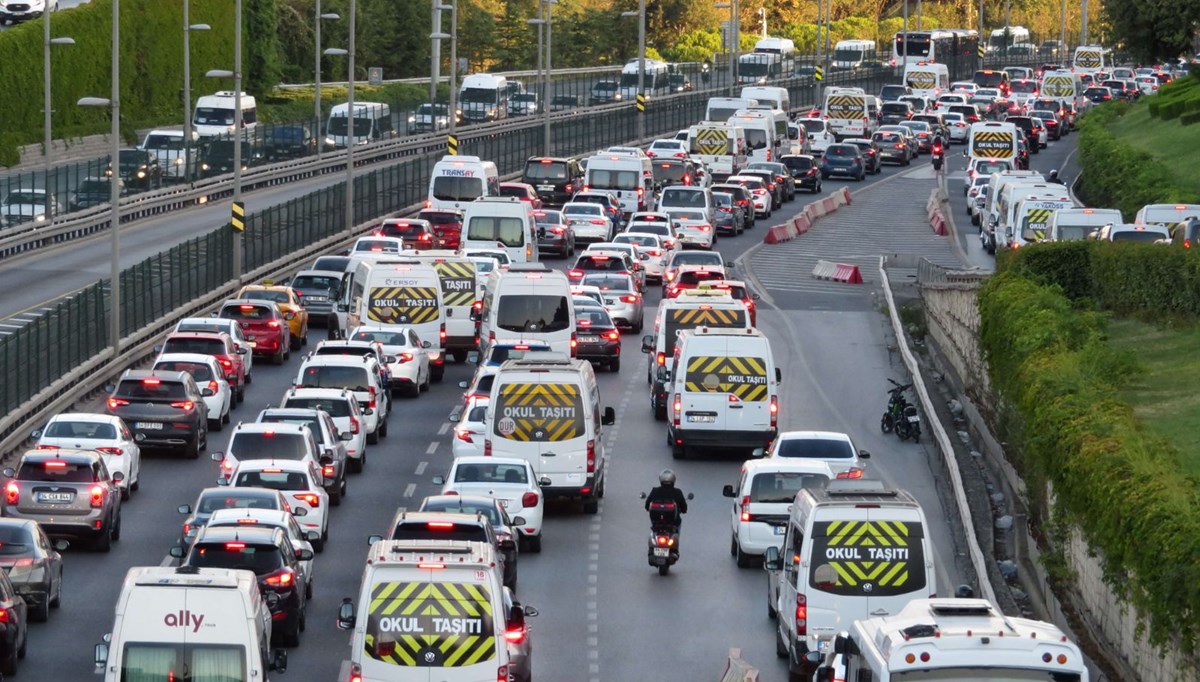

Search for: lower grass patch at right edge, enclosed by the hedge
xmin=1109 ymin=318 xmax=1200 ymax=478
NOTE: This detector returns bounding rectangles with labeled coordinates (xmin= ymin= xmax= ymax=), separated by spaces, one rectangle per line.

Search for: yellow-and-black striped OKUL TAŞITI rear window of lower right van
xmin=809 ymin=520 xmax=925 ymax=597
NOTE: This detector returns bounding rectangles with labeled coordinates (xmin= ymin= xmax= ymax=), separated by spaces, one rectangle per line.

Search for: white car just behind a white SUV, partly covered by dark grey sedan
xmin=228 ymin=456 xmax=329 ymax=552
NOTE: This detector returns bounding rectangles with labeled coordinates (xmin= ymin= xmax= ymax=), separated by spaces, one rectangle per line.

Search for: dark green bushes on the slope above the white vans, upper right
xmin=1079 ymin=102 xmax=1200 ymax=222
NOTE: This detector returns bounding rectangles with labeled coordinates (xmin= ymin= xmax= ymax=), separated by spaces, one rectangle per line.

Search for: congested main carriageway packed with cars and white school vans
xmin=0 ymin=30 xmax=1200 ymax=682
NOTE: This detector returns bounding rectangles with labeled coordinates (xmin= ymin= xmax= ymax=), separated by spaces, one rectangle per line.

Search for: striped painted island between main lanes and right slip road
xmin=746 ymin=166 xmax=962 ymax=310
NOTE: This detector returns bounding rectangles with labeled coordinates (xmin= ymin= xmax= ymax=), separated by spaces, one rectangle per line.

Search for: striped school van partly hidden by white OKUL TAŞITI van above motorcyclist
xmin=642 ymin=288 xmax=751 ymax=420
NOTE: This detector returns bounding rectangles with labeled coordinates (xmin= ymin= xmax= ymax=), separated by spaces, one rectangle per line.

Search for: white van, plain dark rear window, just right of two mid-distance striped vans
xmin=479 ymin=263 xmax=576 ymax=357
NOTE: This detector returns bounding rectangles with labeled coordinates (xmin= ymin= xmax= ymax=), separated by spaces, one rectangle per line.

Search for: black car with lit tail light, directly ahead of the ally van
xmin=170 ymin=526 xmax=312 ymax=646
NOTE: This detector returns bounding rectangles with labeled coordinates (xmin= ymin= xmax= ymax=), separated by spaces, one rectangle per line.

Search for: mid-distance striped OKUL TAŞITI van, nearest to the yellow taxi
xmin=337 ymin=256 xmax=448 ymax=381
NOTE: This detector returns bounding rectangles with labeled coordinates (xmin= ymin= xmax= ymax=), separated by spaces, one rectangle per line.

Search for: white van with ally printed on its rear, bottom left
xmin=96 ymin=566 xmax=287 ymax=682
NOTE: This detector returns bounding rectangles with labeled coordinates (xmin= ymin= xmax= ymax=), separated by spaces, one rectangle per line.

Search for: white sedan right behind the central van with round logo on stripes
xmin=433 ymin=456 xmax=546 ymax=554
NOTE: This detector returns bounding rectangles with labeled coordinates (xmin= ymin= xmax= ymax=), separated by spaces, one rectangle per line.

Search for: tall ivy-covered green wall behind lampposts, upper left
xmin=0 ymin=0 xmax=277 ymax=163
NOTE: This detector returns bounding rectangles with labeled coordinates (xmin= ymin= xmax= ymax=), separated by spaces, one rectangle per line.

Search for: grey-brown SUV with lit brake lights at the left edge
xmin=4 ymin=448 xmax=125 ymax=552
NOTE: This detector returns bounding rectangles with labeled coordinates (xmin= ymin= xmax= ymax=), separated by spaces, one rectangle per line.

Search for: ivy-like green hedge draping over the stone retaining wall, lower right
xmin=979 ymin=268 xmax=1200 ymax=653
